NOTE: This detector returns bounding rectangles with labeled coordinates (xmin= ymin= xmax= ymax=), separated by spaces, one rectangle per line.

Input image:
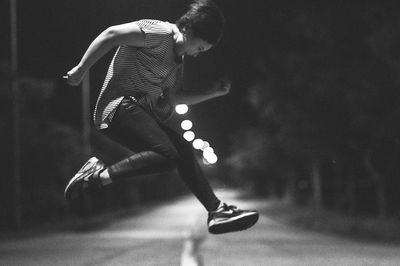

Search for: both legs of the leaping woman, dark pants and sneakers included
xmin=64 ymin=96 xmax=258 ymax=234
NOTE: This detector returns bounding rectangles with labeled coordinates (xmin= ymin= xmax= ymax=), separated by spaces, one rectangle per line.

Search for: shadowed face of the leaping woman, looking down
xmin=178 ymin=29 xmax=212 ymax=57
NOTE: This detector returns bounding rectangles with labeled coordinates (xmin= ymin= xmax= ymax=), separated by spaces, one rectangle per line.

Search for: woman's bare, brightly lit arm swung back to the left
xmin=66 ymin=22 xmax=144 ymax=86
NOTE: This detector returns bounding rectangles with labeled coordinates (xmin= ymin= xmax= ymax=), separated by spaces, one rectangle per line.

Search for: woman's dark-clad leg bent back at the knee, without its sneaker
xmin=105 ymin=98 xmax=178 ymax=181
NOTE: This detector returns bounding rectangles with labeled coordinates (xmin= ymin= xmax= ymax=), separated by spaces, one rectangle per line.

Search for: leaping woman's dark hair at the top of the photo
xmin=176 ymin=0 xmax=225 ymax=45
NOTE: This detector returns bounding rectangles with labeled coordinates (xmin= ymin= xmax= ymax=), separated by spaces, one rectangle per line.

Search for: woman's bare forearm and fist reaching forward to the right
xmin=169 ymin=77 xmax=231 ymax=105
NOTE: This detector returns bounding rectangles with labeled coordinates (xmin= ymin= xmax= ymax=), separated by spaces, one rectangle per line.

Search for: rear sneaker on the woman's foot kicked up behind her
xmin=64 ymin=157 xmax=105 ymax=200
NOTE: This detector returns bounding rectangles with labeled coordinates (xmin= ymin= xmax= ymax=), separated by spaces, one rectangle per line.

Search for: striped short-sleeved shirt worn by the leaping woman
xmin=94 ymin=20 xmax=183 ymax=129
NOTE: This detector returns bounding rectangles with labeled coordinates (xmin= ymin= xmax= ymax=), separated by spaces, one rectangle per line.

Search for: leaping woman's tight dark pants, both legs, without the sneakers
xmin=104 ymin=98 xmax=220 ymax=211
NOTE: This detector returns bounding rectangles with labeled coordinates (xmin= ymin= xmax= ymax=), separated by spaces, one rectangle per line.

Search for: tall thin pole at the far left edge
xmin=10 ymin=0 xmax=21 ymax=229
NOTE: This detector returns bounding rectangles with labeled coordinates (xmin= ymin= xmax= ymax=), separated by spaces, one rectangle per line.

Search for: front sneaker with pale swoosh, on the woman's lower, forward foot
xmin=208 ymin=203 xmax=259 ymax=234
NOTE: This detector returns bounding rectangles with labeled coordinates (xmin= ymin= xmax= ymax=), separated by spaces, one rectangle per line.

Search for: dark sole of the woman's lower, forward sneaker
xmin=208 ymin=212 xmax=259 ymax=235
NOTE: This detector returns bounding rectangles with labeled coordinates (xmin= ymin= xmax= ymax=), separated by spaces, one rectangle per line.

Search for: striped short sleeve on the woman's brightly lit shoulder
xmin=136 ymin=19 xmax=172 ymax=48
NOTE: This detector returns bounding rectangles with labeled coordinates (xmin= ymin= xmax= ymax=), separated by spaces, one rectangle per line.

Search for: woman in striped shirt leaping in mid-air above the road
xmin=65 ymin=0 xmax=258 ymax=234
